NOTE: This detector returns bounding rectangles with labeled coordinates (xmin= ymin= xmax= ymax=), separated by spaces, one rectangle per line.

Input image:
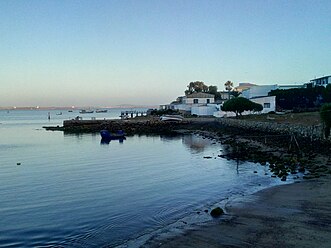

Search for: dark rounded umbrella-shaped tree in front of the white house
xmin=221 ymin=97 xmax=263 ymax=117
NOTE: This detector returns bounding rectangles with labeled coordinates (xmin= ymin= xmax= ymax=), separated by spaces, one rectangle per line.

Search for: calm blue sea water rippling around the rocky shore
xmin=0 ymin=109 xmax=288 ymax=247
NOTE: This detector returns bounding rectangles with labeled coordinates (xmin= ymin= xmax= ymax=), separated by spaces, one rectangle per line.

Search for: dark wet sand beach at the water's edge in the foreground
xmin=143 ymin=175 xmax=331 ymax=248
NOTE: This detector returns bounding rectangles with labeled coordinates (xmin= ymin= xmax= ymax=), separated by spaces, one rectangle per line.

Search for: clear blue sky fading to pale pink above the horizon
xmin=0 ymin=0 xmax=331 ymax=107
